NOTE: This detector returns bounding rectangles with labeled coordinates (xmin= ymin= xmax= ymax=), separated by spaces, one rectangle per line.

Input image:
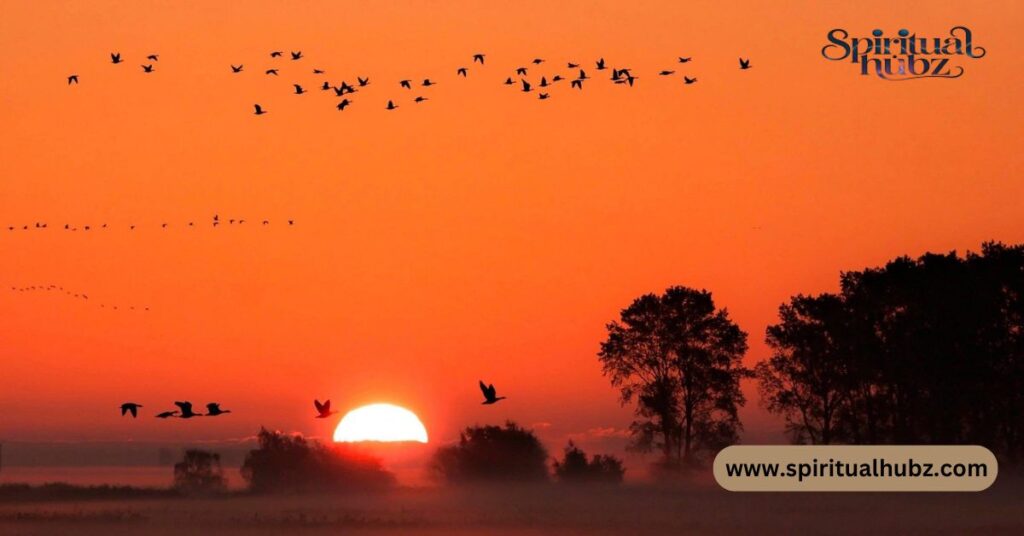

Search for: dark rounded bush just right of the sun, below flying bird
xmin=433 ymin=421 xmax=548 ymax=484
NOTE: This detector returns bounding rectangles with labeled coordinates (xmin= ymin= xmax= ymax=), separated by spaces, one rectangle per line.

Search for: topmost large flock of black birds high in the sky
xmin=68 ymin=50 xmax=751 ymax=116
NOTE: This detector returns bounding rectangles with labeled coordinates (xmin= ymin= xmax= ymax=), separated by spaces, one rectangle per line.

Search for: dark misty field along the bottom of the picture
xmin=0 ymin=480 xmax=1024 ymax=536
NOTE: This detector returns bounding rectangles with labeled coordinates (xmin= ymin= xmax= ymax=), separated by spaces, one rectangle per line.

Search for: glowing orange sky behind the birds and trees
xmin=0 ymin=1 xmax=1024 ymax=455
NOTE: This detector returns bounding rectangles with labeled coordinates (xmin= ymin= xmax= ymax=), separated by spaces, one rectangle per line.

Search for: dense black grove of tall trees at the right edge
xmin=757 ymin=243 xmax=1024 ymax=463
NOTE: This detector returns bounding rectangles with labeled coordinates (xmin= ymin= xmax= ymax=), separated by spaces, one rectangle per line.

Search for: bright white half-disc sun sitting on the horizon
xmin=334 ymin=404 xmax=427 ymax=443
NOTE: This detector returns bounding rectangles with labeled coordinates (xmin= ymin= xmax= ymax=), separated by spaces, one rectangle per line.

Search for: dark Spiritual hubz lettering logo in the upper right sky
xmin=821 ymin=26 xmax=986 ymax=82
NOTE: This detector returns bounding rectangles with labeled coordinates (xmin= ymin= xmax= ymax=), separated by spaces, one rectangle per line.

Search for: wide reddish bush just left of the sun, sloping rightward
xmin=242 ymin=428 xmax=394 ymax=493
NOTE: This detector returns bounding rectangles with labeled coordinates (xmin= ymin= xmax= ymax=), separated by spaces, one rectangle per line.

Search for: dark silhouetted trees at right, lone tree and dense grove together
xmin=599 ymin=243 xmax=1024 ymax=466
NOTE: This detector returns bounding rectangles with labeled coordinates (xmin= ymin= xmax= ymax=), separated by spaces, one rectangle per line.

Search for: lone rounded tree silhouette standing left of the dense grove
xmin=598 ymin=287 xmax=750 ymax=466
